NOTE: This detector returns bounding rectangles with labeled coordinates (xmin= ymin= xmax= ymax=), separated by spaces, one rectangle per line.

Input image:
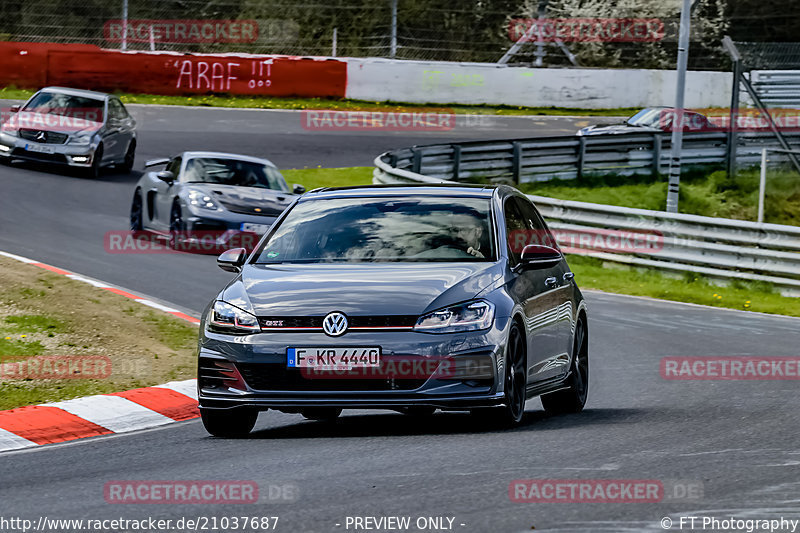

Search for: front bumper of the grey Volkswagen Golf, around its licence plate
xmin=198 ymin=321 xmax=506 ymax=411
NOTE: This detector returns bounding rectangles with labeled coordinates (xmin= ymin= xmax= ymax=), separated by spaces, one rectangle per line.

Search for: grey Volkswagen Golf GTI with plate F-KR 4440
xmin=198 ymin=186 xmax=589 ymax=437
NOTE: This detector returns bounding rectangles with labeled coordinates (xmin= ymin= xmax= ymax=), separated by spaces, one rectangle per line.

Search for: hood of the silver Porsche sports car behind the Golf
xmin=186 ymin=183 xmax=296 ymax=217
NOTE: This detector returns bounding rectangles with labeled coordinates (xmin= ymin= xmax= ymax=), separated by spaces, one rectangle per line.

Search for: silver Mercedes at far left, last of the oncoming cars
xmin=0 ymin=87 xmax=136 ymax=178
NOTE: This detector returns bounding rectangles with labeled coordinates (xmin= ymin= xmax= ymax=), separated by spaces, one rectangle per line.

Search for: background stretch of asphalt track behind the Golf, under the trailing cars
xmin=0 ymin=101 xmax=607 ymax=311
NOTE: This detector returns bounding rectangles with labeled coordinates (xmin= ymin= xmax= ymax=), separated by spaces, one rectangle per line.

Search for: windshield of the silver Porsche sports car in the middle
xmin=183 ymin=157 xmax=289 ymax=192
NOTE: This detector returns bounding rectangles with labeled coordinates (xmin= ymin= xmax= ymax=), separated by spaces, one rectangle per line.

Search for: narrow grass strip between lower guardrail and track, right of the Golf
xmin=567 ymin=255 xmax=800 ymax=316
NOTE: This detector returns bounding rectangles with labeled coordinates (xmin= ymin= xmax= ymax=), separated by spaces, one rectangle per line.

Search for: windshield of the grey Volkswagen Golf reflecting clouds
xmin=256 ymin=197 xmax=494 ymax=264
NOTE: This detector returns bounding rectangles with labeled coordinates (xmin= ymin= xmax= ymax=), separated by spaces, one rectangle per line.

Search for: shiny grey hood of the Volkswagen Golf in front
xmin=220 ymin=262 xmax=502 ymax=316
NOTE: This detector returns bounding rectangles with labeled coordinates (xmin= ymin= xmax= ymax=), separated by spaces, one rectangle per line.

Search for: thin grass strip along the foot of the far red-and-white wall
xmin=0 ymin=86 xmax=639 ymax=117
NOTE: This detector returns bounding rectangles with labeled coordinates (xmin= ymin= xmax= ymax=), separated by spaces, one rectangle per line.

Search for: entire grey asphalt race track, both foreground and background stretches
xmin=0 ymin=106 xmax=800 ymax=532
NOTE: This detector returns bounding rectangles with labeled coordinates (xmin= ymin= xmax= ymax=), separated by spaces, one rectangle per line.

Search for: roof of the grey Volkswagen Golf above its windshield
xmin=302 ymin=183 xmax=506 ymax=201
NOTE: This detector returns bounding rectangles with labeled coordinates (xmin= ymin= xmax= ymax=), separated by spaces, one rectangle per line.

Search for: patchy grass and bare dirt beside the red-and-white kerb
xmin=0 ymin=258 xmax=197 ymax=410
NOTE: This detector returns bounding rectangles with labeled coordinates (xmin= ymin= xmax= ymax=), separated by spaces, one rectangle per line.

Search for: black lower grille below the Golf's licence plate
xmin=236 ymin=363 xmax=427 ymax=392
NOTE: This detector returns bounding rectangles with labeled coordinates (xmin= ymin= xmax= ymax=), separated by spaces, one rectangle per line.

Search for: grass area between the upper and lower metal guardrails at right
xmin=520 ymin=169 xmax=800 ymax=226
